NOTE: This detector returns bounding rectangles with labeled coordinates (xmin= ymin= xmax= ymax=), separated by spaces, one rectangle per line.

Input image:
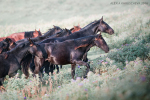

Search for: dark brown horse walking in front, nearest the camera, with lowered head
xmin=25 ymin=33 xmax=109 ymax=79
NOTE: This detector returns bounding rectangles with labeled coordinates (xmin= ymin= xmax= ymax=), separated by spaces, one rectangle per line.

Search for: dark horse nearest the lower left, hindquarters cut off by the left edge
xmin=0 ymin=39 xmax=42 ymax=85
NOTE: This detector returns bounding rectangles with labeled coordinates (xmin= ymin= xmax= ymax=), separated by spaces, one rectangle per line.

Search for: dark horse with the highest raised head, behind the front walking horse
xmin=30 ymin=17 xmax=114 ymax=73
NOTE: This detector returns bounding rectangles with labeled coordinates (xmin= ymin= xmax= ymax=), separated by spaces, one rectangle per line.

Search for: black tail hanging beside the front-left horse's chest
xmin=21 ymin=53 xmax=32 ymax=78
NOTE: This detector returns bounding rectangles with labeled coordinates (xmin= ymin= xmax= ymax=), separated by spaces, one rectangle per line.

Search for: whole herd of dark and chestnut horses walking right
xmin=0 ymin=17 xmax=114 ymax=85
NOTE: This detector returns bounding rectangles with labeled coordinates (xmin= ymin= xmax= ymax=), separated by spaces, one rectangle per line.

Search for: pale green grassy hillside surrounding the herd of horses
xmin=0 ymin=0 xmax=150 ymax=100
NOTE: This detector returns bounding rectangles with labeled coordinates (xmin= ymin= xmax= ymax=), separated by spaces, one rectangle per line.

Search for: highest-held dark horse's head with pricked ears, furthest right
xmin=95 ymin=17 xmax=114 ymax=35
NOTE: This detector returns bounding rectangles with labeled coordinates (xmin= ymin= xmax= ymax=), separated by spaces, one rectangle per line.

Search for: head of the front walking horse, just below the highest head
xmin=94 ymin=33 xmax=109 ymax=53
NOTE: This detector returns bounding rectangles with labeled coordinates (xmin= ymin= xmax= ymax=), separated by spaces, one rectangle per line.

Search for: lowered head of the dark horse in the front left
xmin=28 ymin=38 xmax=47 ymax=58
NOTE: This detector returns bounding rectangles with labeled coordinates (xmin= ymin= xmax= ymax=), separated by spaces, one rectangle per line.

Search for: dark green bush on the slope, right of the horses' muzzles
xmin=107 ymin=43 xmax=149 ymax=64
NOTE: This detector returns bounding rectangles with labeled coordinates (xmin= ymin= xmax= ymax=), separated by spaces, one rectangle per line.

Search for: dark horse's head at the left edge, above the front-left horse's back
xmin=0 ymin=38 xmax=14 ymax=53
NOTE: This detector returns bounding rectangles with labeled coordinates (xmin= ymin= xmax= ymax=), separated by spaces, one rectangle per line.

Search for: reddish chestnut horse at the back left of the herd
xmin=0 ymin=29 xmax=42 ymax=42
